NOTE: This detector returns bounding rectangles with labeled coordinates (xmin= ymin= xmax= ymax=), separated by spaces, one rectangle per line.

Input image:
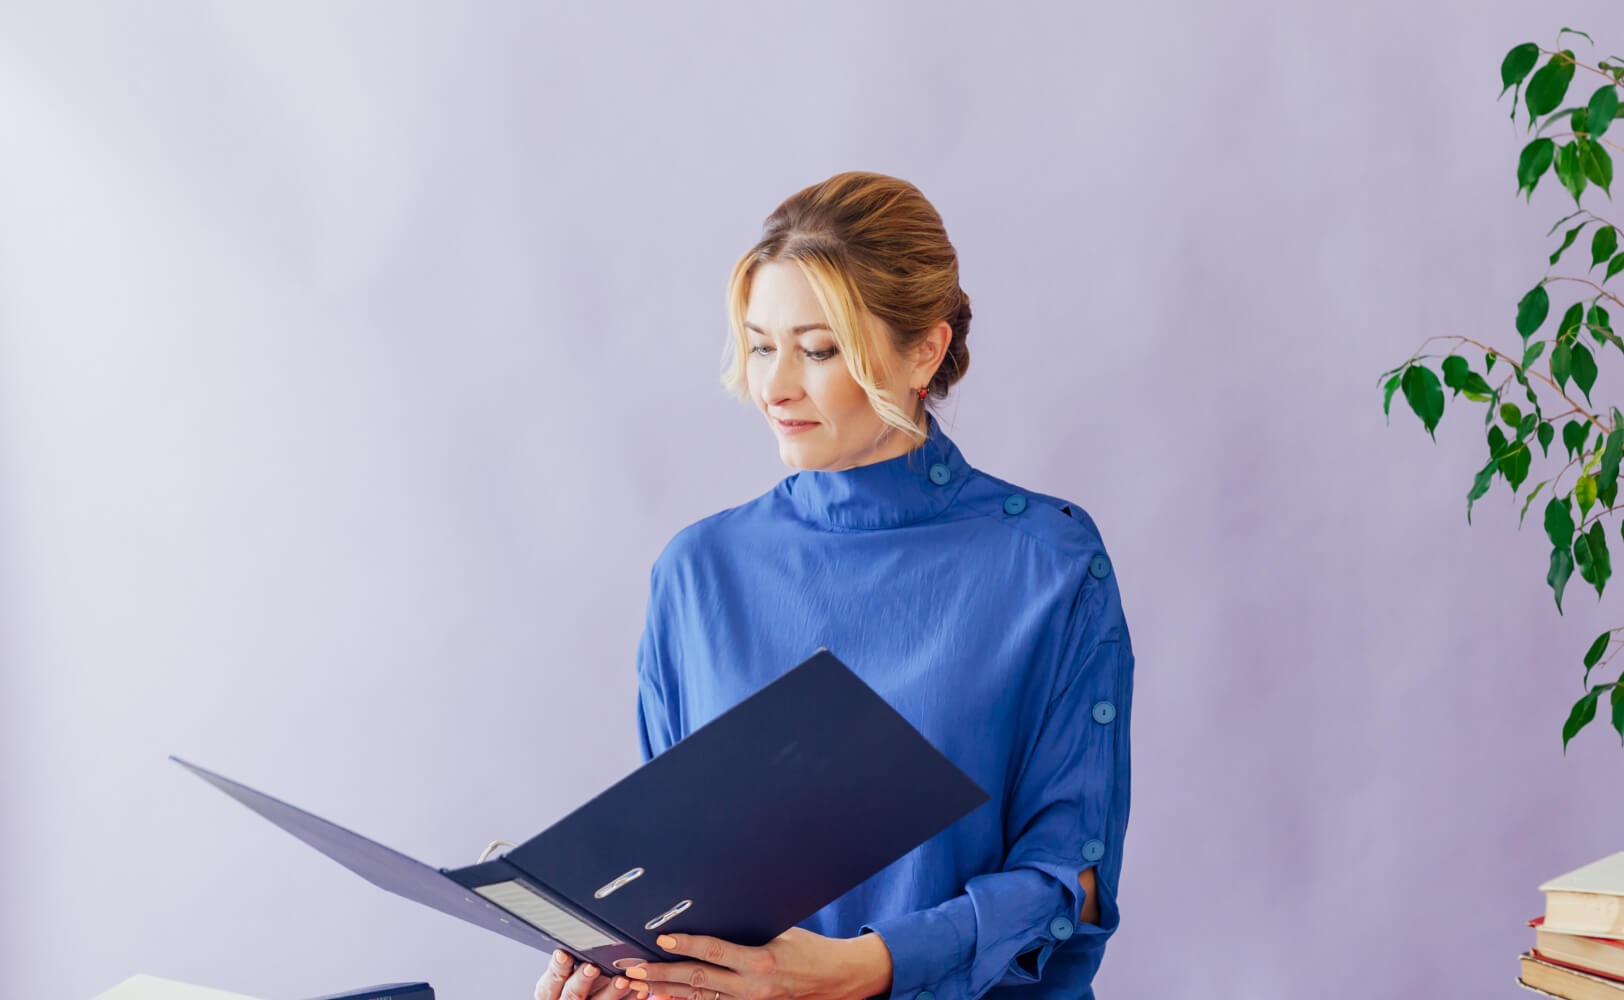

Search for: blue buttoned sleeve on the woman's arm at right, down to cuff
xmin=862 ymin=578 xmax=1134 ymax=1000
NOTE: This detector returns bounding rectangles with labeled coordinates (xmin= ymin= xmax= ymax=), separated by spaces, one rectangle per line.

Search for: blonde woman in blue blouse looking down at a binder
xmin=536 ymin=172 xmax=1134 ymax=1000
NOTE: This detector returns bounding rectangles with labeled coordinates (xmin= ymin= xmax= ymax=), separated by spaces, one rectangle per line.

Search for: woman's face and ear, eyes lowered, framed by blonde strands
xmin=745 ymin=261 xmax=945 ymax=471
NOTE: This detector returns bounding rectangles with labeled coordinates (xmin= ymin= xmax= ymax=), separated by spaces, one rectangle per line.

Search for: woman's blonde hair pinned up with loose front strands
xmin=721 ymin=170 xmax=970 ymax=443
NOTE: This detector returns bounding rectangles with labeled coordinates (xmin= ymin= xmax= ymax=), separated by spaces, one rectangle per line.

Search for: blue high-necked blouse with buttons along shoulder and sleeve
xmin=637 ymin=416 xmax=1134 ymax=1000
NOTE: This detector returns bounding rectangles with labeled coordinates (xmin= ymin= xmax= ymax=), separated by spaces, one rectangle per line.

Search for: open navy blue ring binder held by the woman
xmin=171 ymin=649 xmax=989 ymax=969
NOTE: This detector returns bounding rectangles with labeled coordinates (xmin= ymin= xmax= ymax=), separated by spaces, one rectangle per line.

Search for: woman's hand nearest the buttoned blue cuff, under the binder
xmin=625 ymin=927 xmax=892 ymax=1000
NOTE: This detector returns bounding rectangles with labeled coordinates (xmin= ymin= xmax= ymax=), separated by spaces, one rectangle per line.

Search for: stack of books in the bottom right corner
xmin=1517 ymin=851 xmax=1624 ymax=1000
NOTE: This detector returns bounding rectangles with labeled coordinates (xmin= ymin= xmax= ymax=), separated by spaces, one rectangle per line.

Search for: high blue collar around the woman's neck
xmin=784 ymin=414 xmax=970 ymax=529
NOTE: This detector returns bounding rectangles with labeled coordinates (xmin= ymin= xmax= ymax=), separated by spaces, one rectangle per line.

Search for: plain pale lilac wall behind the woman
xmin=0 ymin=0 xmax=1624 ymax=1000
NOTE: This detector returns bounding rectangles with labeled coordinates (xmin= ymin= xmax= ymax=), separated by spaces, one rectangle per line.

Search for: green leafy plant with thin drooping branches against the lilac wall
xmin=1380 ymin=28 xmax=1624 ymax=755
